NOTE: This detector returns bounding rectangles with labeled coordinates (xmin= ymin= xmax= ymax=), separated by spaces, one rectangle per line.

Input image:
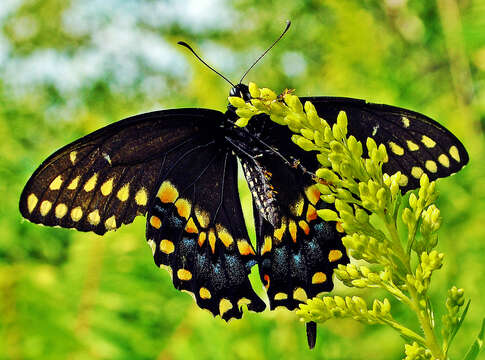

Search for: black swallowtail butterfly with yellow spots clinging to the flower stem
xmin=20 ymin=21 xmax=468 ymax=348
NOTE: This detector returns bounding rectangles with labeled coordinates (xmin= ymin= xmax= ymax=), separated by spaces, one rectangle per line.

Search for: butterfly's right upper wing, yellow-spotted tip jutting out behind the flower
xmin=300 ymin=97 xmax=468 ymax=191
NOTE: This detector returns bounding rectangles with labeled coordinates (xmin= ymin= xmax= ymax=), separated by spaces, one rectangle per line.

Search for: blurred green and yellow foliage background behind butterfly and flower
xmin=0 ymin=0 xmax=485 ymax=360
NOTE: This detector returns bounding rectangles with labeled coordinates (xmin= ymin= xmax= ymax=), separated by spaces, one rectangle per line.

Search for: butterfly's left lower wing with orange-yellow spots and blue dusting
xmin=146 ymin=144 xmax=265 ymax=321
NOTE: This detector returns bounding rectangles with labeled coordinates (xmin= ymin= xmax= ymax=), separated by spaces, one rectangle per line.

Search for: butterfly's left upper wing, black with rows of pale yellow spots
xmin=20 ymin=109 xmax=223 ymax=234
